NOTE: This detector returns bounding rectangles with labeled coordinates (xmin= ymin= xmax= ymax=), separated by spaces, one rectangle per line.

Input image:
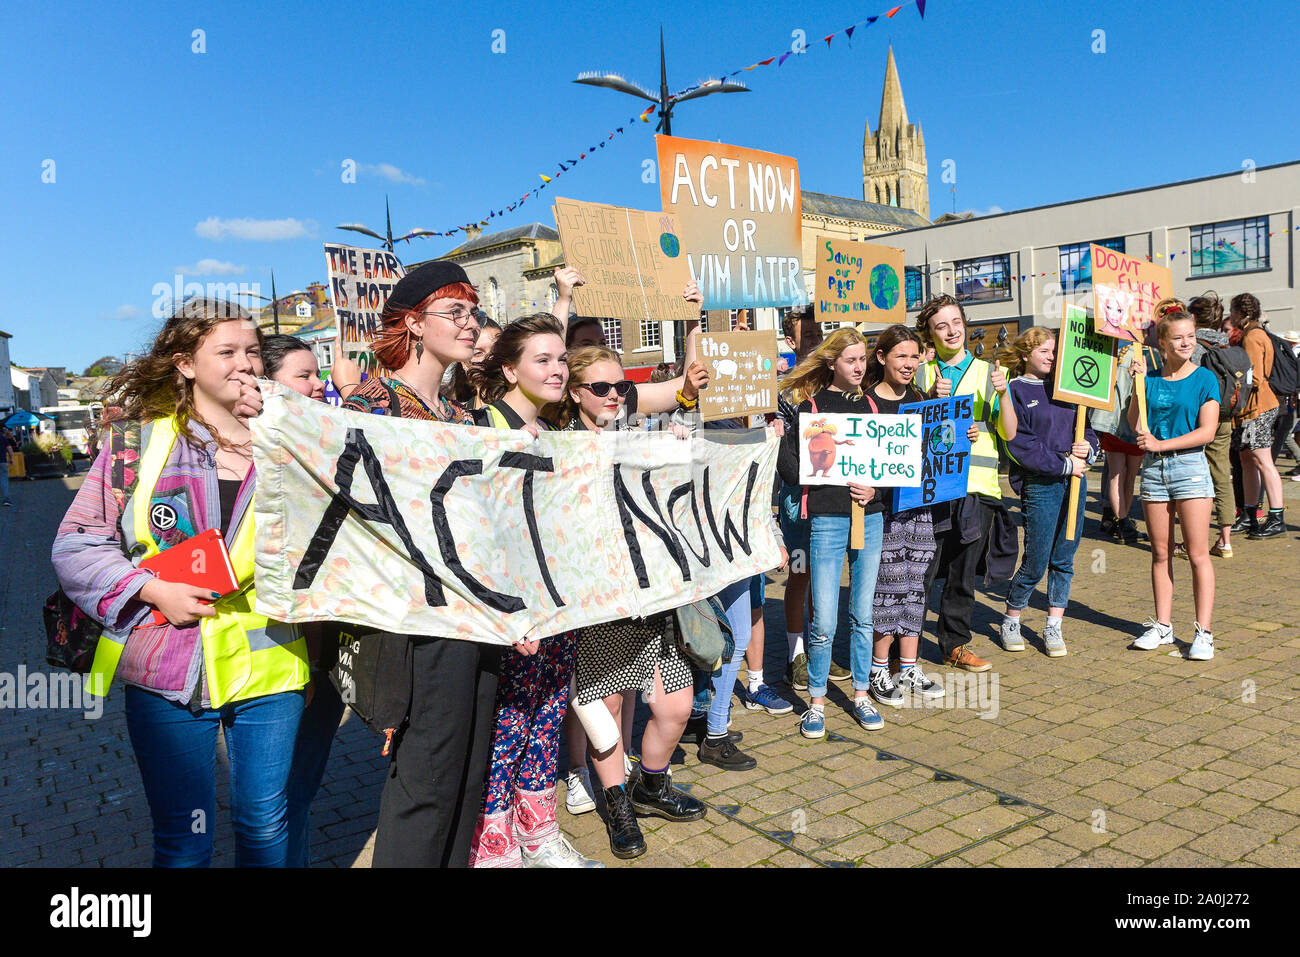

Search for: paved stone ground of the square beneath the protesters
xmin=0 ymin=462 xmax=1300 ymax=867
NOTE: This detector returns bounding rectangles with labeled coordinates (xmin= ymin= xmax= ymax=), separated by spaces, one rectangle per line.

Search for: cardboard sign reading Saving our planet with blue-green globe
xmin=813 ymin=237 xmax=907 ymax=322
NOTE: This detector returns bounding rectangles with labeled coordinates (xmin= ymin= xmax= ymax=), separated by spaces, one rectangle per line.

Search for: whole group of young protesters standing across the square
xmin=53 ymin=261 xmax=1295 ymax=867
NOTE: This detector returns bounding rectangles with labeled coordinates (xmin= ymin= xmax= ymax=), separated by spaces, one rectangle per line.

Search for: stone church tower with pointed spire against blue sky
xmin=862 ymin=46 xmax=930 ymax=220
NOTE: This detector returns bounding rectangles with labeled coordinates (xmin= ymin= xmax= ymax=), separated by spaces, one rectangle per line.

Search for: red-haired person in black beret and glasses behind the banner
xmin=343 ymin=261 xmax=514 ymax=867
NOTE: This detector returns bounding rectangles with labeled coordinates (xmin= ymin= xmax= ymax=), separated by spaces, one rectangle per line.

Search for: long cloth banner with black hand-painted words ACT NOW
xmin=252 ymin=382 xmax=780 ymax=644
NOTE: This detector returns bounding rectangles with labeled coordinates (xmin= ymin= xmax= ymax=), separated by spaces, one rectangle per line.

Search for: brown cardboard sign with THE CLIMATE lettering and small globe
xmin=554 ymin=199 xmax=699 ymax=322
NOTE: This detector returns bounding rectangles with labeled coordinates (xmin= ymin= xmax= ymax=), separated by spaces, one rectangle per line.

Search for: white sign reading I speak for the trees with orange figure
xmin=800 ymin=412 xmax=920 ymax=488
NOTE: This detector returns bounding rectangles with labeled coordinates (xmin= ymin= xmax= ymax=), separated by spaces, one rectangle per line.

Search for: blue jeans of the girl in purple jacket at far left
xmin=126 ymin=687 xmax=303 ymax=867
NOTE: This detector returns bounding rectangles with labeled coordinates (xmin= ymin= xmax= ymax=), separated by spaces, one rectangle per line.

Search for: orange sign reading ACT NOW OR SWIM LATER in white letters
xmin=655 ymin=137 xmax=807 ymax=309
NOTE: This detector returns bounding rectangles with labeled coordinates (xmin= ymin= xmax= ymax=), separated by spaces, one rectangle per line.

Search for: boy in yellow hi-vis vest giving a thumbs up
xmin=917 ymin=295 xmax=1017 ymax=671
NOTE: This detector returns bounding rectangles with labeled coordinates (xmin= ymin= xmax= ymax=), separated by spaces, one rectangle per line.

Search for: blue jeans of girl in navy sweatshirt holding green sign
xmin=1006 ymin=476 xmax=1087 ymax=610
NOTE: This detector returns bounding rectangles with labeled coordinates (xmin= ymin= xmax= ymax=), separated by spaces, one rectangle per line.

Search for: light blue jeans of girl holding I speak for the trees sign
xmin=807 ymin=512 xmax=884 ymax=698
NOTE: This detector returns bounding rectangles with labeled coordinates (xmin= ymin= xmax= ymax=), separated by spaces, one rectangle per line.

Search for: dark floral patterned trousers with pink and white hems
xmin=469 ymin=632 xmax=577 ymax=867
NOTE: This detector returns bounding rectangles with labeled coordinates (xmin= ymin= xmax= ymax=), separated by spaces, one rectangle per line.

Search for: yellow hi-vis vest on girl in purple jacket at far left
xmin=86 ymin=416 xmax=308 ymax=709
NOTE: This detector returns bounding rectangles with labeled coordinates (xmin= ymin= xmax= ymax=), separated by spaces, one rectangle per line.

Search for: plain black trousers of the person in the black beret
xmin=373 ymin=638 xmax=502 ymax=867
